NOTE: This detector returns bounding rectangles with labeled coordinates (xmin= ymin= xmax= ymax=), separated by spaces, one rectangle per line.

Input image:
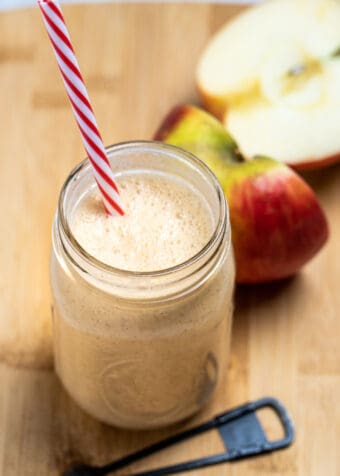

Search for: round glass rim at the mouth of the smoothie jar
xmin=58 ymin=140 xmax=230 ymax=279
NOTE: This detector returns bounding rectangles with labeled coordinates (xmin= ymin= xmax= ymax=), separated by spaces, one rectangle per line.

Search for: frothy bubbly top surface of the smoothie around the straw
xmin=71 ymin=171 xmax=213 ymax=271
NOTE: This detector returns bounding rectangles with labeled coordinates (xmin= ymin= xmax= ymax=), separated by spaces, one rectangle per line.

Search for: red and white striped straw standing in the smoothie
xmin=38 ymin=0 xmax=124 ymax=215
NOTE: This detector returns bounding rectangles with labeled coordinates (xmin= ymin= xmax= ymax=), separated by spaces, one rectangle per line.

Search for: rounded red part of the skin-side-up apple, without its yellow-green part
xmin=228 ymin=165 xmax=328 ymax=284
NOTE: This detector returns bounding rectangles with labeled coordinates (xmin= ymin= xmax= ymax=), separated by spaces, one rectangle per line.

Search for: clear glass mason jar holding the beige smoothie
xmin=51 ymin=141 xmax=234 ymax=428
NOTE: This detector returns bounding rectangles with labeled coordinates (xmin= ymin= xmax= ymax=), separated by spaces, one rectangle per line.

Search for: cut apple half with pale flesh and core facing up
xmin=196 ymin=0 xmax=340 ymax=169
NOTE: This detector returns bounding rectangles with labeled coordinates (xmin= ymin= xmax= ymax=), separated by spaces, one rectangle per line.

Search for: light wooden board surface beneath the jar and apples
xmin=0 ymin=4 xmax=340 ymax=476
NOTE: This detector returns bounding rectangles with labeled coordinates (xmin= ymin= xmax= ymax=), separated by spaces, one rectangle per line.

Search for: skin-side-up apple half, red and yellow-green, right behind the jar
xmin=154 ymin=105 xmax=328 ymax=283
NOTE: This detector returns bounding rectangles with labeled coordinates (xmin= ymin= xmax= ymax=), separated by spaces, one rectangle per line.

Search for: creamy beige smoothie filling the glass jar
xmin=52 ymin=143 xmax=234 ymax=428
